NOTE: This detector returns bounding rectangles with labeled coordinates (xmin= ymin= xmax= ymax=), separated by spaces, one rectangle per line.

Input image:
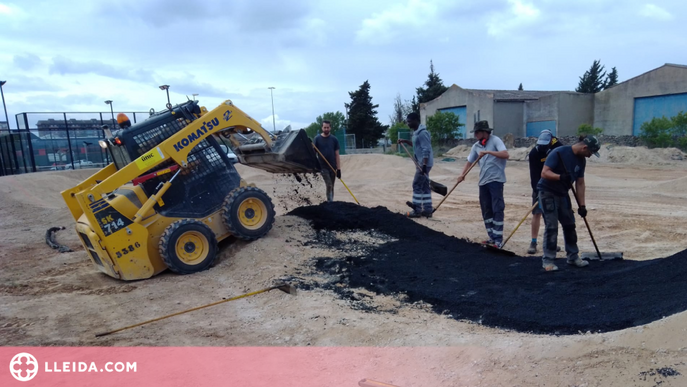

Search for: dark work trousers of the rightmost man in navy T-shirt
xmin=539 ymin=191 xmax=580 ymax=264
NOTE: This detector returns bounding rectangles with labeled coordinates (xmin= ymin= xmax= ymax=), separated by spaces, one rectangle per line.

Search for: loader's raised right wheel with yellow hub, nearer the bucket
xmin=222 ymin=187 xmax=274 ymax=241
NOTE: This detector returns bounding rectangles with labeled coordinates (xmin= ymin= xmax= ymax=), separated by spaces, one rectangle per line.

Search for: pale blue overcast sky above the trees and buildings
xmin=0 ymin=0 xmax=687 ymax=129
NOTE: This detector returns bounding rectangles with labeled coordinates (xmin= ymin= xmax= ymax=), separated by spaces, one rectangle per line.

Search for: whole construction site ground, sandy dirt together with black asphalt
xmin=0 ymin=146 xmax=687 ymax=387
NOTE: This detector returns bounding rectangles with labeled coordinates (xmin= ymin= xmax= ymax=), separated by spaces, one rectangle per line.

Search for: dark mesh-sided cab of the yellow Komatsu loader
xmin=102 ymin=101 xmax=241 ymax=218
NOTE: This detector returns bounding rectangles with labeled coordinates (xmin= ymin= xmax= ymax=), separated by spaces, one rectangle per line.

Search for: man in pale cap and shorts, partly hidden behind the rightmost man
xmin=527 ymin=129 xmax=562 ymax=254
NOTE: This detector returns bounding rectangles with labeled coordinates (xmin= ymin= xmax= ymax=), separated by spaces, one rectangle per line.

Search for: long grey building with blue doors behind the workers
xmin=420 ymin=64 xmax=687 ymax=138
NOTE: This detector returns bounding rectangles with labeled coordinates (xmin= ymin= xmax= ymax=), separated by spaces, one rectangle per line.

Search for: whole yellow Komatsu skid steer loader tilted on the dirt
xmin=62 ymin=100 xmax=319 ymax=280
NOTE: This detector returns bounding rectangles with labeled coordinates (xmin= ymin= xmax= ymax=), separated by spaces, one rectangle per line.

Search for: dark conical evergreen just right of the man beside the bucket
xmin=346 ymin=81 xmax=388 ymax=148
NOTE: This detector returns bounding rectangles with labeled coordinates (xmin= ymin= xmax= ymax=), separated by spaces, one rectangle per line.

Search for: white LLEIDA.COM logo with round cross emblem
xmin=10 ymin=352 xmax=136 ymax=382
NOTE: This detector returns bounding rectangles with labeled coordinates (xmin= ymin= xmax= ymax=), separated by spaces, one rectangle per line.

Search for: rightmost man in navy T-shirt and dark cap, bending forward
xmin=537 ymin=135 xmax=601 ymax=271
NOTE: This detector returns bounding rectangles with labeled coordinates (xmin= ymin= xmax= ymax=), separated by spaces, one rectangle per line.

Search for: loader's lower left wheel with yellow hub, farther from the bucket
xmin=158 ymin=219 xmax=217 ymax=274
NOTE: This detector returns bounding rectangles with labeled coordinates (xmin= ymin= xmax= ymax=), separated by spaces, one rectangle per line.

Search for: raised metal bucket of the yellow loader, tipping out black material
xmin=234 ymin=129 xmax=320 ymax=173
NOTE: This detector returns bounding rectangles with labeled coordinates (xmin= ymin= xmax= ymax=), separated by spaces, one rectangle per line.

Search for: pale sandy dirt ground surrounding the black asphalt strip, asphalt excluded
xmin=0 ymin=146 xmax=687 ymax=387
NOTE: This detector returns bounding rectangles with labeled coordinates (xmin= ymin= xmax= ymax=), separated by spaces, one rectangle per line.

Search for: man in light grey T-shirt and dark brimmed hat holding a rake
xmin=458 ymin=121 xmax=509 ymax=248
